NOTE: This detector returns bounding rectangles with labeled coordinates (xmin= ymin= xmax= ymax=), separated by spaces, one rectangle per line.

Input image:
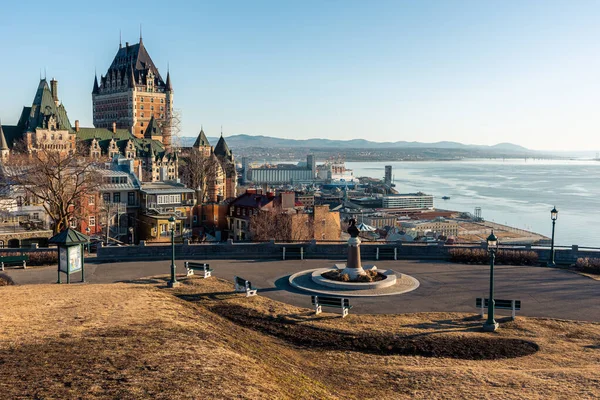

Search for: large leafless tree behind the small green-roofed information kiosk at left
xmin=4 ymin=143 xmax=101 ymax=233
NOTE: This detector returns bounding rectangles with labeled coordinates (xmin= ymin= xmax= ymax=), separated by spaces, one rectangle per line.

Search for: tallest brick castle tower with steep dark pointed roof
xmin=92 ymin=37 xmax=173 ymax=148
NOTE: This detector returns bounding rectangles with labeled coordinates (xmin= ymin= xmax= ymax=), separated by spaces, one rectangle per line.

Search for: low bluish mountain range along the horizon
xmin=181 ymin=134 xmax=533 ymax=153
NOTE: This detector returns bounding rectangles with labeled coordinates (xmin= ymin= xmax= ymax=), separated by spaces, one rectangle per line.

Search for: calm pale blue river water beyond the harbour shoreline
xmin=346 ymin=160 xmax=600 ymax=247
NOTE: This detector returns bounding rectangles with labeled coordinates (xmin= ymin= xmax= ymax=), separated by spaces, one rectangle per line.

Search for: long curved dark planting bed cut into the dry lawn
xmin=200 ymin=303 xmax=539 ymax=360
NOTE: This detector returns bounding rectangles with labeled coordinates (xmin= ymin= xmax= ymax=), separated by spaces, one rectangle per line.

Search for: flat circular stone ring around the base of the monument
xmin=289 ymin=268 xmax=419 ymax=297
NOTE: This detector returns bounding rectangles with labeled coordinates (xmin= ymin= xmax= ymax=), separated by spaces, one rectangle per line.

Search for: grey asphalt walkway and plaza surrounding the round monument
xmin=6 ymin=260 xmax=600 ymax=322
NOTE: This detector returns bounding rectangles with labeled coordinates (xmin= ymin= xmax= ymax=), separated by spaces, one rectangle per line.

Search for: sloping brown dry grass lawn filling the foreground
xmin=0 ymin=278 xmax=600 ymax=399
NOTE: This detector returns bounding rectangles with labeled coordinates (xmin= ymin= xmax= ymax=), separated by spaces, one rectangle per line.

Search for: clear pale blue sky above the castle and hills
xmin=0 ymin=0 xmax=600 ymax=150
